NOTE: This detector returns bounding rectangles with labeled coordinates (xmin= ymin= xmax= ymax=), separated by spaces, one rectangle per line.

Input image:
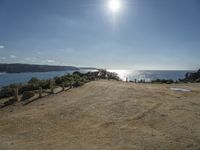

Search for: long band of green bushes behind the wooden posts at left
xmin=0 ymin=70 xmax=119 ymax=99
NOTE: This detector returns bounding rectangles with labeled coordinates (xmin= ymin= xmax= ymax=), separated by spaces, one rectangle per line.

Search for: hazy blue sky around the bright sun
xmin=0 ymin=0 xmax=200 ymax=70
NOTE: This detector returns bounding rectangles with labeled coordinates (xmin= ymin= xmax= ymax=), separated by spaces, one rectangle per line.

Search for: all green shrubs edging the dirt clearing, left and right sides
xmin=0 ymin=70 xmax=200 ymax=101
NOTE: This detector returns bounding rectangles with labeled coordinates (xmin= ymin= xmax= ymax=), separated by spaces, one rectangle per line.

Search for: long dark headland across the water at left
xmin=0 ymin=64 xmax=79 ymax=73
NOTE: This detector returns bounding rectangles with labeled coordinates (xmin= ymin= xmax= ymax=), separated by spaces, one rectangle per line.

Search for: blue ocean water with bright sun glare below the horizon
xmin=0 ymin=69 xmax=191 ymax=87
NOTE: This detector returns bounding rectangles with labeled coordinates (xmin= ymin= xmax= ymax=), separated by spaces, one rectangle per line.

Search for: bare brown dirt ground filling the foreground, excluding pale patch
xmin=0 ymin=80 xmax=200 ymax=150
